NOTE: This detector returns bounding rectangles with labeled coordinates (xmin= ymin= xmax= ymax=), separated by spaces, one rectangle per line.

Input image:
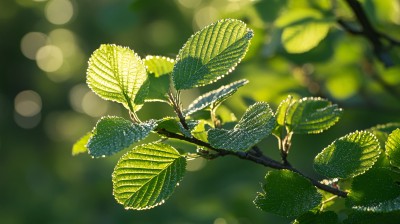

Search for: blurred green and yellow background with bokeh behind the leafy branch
xmin=0 ymin=0 xmax=400 ymax=224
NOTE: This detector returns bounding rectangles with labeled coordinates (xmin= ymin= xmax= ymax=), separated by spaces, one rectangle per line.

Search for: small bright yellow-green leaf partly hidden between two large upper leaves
xmin=144 ymin=55 xmax=175 ymax=78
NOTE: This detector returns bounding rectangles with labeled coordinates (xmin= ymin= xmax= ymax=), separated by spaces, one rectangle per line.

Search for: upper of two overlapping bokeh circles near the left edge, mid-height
xmin=14 ymin=90 xmax=42 ymax=117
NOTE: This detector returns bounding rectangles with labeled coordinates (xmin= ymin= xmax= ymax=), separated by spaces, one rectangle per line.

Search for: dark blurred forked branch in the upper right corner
xmin=337 ymin=0 xmax=400 ymax=67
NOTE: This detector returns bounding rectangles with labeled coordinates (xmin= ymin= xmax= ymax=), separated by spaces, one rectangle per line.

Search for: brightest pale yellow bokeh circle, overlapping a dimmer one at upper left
xmin=36 ymin=45 xmax=64 ymax=72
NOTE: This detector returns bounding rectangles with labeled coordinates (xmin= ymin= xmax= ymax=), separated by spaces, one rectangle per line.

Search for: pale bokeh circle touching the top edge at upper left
xmin=45 ymin=0 xmax=74 ymax=25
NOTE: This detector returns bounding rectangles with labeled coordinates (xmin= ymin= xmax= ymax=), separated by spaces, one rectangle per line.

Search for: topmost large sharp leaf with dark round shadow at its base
xmin=172 ymin=19 xmax=253 ymax=90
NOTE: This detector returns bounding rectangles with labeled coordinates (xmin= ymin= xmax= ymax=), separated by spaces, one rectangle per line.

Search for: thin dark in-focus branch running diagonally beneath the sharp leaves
xmin=157 ymin=129 xmax=347 ymax=198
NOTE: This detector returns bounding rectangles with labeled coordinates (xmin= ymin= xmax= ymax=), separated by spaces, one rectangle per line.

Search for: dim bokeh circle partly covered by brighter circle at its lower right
xmin=21 ymin=32 xmax=48 ymax=60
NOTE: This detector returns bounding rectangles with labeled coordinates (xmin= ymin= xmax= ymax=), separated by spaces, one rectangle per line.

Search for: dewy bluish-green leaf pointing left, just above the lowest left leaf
xmin=87 ymin=116 xmax=156 ymax=158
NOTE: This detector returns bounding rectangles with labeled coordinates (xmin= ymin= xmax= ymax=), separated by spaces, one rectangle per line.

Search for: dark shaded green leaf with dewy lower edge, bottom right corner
xmin=346 ymin=168 xmax=400 ymax=212
